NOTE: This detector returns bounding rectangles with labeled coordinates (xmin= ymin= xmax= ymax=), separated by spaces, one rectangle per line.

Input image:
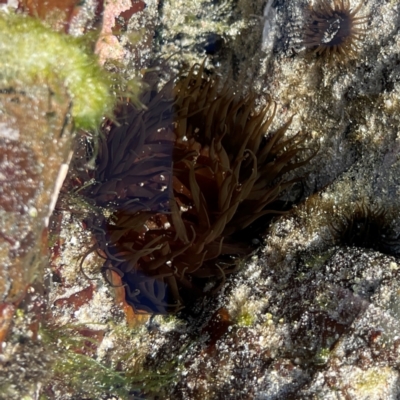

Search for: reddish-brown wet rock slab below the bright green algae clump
xmin=0 ymin=86 xmax=72 ymax=310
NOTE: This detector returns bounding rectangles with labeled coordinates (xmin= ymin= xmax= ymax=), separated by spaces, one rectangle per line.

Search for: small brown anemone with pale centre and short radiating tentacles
xmin=303 ymin=0 xmax=368 ymax=63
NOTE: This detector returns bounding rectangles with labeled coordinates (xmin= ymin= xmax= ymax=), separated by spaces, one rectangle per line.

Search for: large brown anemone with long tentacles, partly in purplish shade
xmin=85 ymin=66 xmax=313 ymax=313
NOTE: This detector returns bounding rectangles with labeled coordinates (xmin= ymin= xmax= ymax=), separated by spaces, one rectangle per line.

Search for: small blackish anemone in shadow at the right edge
xmin=329 ymin=203 xmax=400 ymax=255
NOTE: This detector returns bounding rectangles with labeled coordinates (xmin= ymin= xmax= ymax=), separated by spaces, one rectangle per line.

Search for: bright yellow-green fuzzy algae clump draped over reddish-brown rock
xmin=0 ymin=12 xmax=114 ymax=129
